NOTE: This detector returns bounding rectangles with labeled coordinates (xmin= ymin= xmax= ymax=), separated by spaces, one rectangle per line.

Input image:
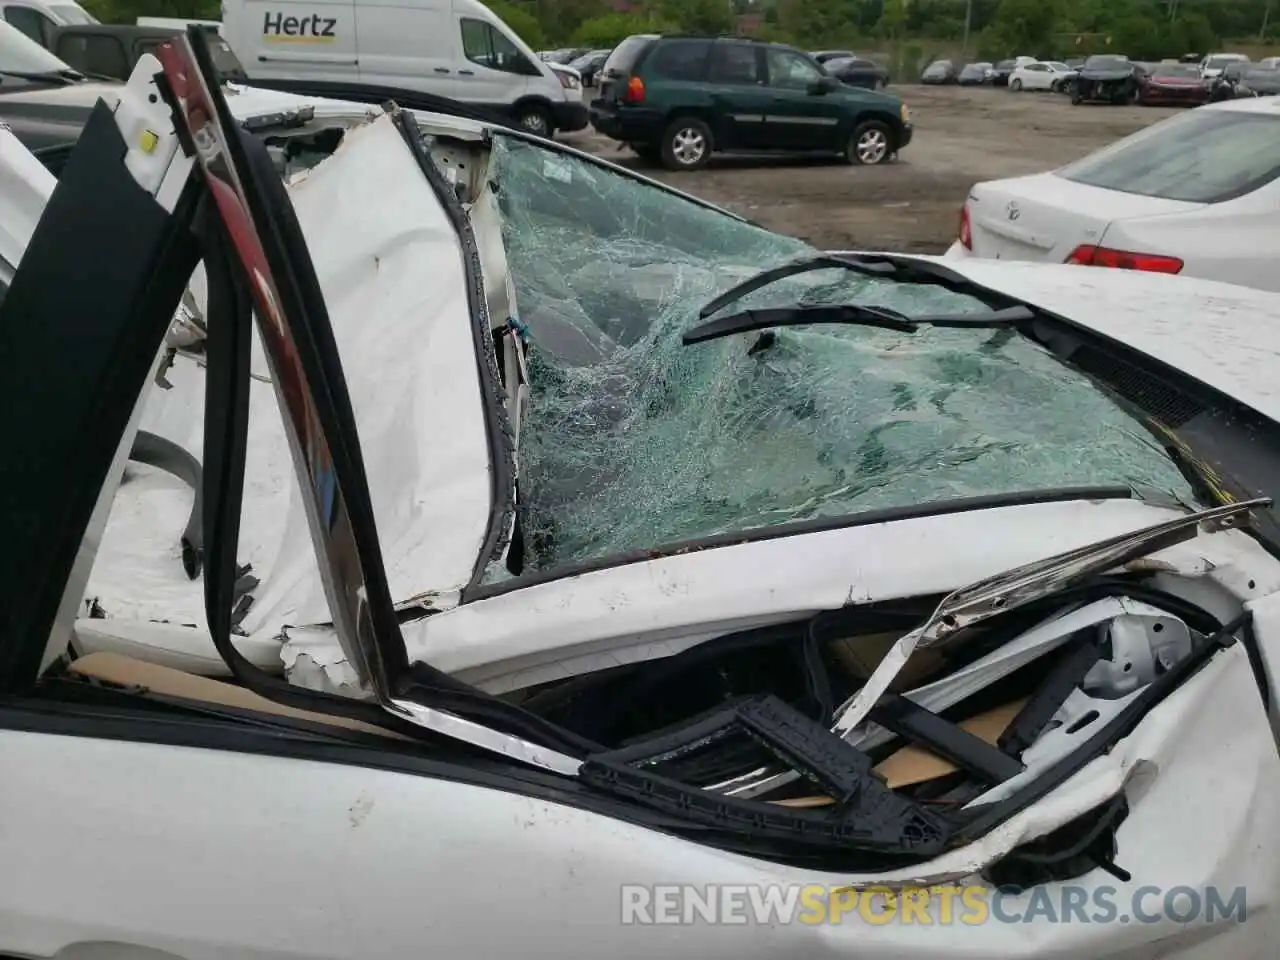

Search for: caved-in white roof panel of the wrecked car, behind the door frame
xmin=87 ymin=119 xmax=490 ymax=636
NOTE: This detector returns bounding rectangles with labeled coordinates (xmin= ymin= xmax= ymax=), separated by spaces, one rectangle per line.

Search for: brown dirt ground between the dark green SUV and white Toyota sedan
xmin=564 ymin=86 xmax=1170 ymax=253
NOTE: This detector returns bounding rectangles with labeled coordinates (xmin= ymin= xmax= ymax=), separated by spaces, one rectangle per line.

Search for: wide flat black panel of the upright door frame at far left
xmin=0 ymin=101 xmax=198 ymax=691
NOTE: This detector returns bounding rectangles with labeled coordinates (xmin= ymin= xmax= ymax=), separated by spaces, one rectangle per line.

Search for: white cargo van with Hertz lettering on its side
xmin=221 ymin=0 xmax=588 ymax=136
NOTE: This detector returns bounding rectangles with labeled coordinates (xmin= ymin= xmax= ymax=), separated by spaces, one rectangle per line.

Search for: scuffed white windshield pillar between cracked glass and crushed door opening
xmin=284 ymin=500 xmax=1280 ymax=694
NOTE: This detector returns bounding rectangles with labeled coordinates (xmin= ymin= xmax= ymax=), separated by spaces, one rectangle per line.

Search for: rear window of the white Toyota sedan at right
xmin=1057 ymin=110 xmax=1280 ymax=204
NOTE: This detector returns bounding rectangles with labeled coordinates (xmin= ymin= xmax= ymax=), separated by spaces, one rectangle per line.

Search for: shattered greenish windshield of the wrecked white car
xmin=489 ymin=136 xmax=1194 ymax=577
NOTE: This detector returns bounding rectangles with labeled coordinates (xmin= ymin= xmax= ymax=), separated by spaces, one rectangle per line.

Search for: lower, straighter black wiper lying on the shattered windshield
xmin=682 ymin=303 xmax=1036 ymax=347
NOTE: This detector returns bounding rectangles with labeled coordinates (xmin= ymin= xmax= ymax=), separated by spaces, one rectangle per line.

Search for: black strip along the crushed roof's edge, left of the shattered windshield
xmin=392 ymin=111 xmax=516 ymax=585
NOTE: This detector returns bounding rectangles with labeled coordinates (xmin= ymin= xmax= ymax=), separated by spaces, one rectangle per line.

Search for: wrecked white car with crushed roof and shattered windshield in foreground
xmin=0 ymin=33 xmax=1280 ymax=960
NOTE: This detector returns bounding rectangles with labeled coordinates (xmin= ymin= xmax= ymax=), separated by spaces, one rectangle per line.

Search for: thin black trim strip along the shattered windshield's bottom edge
xmin=462 ymin=485 xmax=1135 ymax=603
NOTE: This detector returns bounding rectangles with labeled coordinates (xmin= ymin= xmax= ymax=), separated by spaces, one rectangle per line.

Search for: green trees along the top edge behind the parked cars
xmin=84 ymin=0 xmax=1280 ymax=59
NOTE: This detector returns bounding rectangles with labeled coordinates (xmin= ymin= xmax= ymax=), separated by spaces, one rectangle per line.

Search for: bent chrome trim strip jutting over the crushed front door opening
xmin=707 ymin=497 xmax=1272 ymax=797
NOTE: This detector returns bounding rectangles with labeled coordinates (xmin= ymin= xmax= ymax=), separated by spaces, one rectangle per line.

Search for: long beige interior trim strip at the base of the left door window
xmin=68 ymin=650 xmax=411 ymax=740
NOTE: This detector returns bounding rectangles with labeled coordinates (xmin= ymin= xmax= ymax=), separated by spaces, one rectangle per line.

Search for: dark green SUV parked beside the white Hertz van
xmin=591 ymin=35 xmax=911 ymax=170
